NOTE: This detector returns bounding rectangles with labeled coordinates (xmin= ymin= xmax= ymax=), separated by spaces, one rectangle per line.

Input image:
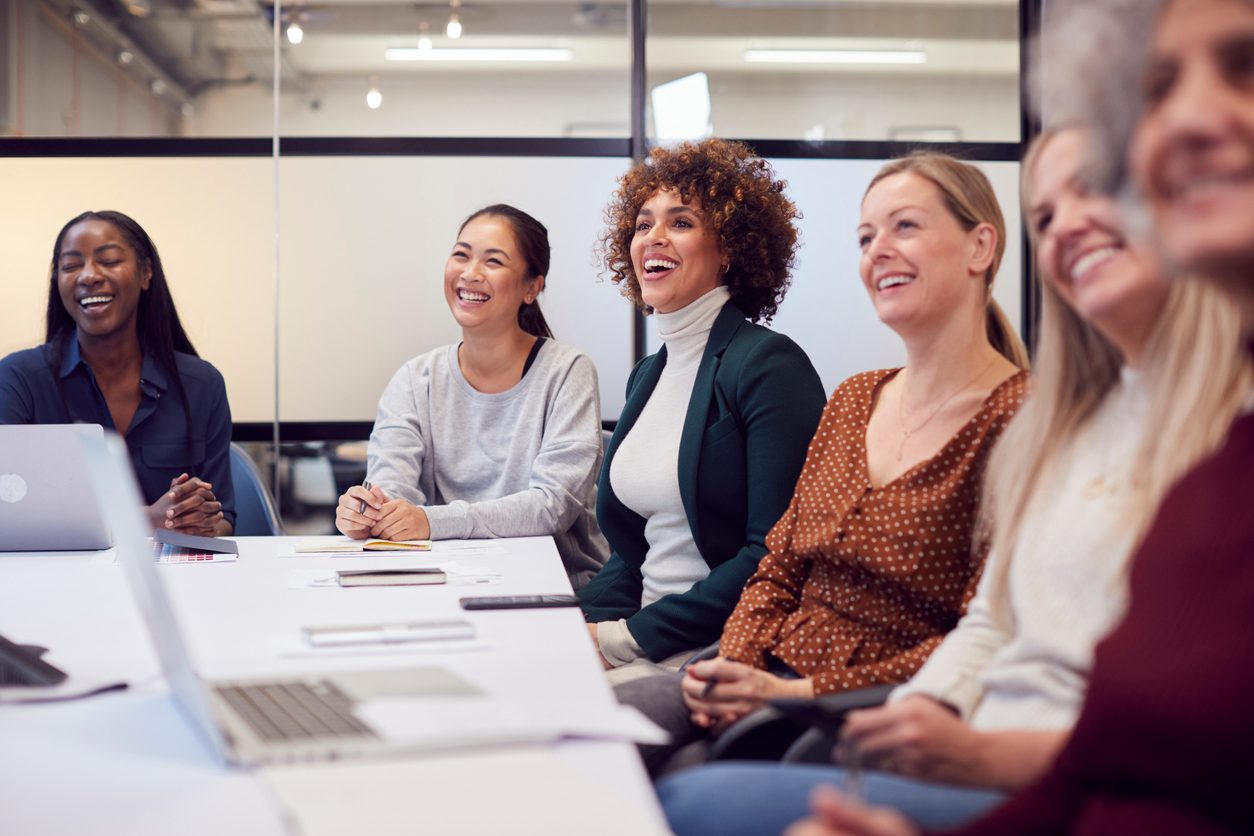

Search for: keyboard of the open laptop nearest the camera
xmin=217 ymin=679 xmax=375 ymax=742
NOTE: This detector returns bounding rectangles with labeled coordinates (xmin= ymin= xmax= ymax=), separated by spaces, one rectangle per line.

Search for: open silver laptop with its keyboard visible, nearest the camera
xmin=82 ymin=434 xmax=556 ymax=765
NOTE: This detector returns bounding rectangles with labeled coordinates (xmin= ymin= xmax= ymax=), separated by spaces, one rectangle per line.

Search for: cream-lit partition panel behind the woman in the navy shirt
xmin=0 ymin=157 xmax=275 ymax=421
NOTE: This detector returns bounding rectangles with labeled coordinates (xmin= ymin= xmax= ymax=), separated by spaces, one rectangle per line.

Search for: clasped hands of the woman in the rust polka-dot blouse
xmin=680 ymin=657 xmax=814 ymax=729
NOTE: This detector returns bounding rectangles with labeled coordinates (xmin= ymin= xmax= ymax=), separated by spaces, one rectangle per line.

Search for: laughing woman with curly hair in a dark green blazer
xmin=579 ymin=139 xmax=824 ymax=682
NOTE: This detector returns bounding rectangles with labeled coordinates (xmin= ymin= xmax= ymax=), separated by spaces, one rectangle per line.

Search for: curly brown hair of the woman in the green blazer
xmin=599 ymin=139 xmax=801 ymax=322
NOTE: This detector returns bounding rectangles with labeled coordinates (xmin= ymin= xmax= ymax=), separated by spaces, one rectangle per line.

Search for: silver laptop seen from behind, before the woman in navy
xmin=0 ymin=424 xmax=111 ymax=551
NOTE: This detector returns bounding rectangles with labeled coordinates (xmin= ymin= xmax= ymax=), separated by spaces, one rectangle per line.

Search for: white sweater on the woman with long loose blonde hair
xmin=892 ymin=368 xmax=1149 ymax=731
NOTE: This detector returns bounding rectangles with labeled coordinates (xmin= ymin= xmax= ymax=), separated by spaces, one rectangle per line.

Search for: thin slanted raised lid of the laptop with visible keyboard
xmin=78 ymin=427 xmax=227 ymax=762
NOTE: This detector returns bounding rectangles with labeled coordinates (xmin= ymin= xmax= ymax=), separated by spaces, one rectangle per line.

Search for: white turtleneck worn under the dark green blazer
xmin=597 ymin=286 xmax=731 ymax=666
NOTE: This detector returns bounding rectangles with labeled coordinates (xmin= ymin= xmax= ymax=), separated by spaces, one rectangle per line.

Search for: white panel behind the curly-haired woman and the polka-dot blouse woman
xmin=647 ymin=159 xmax=1022 ymax=392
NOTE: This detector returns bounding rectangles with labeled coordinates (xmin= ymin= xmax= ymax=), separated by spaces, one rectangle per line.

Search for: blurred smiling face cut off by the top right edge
xmin=1131 ymin=0 xmax=1254 ymax=284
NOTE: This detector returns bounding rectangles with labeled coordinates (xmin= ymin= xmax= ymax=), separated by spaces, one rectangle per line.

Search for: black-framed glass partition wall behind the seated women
xmin=0 ymin=0 xmax=1035 ymax=531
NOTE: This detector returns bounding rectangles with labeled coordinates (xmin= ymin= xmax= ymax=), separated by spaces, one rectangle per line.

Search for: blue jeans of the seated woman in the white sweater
xmin=657 ymin=762 xmax=1006 ymax=836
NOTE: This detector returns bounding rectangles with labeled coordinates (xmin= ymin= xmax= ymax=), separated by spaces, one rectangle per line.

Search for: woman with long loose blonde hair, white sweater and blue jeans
xmin=660 ymin=129 xmax=1250 ymax=836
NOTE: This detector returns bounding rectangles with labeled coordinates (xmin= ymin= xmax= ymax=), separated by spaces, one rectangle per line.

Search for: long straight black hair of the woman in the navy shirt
xmin=44 ymin=211 xmax=199 ymax=446
